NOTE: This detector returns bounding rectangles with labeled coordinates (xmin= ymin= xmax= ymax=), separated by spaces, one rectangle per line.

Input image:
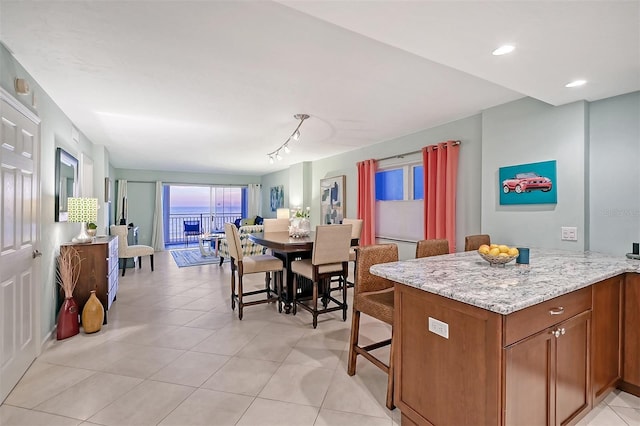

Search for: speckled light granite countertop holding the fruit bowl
xmin=371 ymin=248 xmax=640 ymax=315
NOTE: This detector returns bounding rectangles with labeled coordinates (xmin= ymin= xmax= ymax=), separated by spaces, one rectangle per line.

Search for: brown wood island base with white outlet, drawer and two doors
xmin=394 ymin=285 xmax=592 ymax=425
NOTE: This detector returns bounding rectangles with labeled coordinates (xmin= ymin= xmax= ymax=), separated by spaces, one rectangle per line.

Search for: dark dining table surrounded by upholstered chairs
xmin=249 ymin=231 xmax=358 ymax=314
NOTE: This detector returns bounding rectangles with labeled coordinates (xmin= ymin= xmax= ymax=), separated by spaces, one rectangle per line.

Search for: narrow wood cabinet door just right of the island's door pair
xmin=591 ymin=277 xmax=622 ymax=404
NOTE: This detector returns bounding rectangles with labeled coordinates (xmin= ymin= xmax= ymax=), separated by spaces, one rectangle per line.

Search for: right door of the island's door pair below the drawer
xmin=554 ymin=311 xmax=591 ymax=425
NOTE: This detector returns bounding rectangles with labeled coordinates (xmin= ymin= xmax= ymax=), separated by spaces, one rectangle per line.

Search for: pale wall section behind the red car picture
xmin=481 ymin=98 xmax=587 ymax=251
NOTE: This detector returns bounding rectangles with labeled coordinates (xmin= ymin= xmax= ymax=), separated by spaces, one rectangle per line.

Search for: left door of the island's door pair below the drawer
xmin=505 ymin=329 xmax=556 ymax=426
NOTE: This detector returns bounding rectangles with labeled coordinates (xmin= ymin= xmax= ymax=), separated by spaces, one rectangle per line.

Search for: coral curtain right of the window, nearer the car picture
xmin=422 ymin=141 xmax=460 ymax=253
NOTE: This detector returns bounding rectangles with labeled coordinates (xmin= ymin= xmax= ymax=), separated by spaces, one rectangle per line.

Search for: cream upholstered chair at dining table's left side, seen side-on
xmin=224 ymin=223 xmax=283 ymax=320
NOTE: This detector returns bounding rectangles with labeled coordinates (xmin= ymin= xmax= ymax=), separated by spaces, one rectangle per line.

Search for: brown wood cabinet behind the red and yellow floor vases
xmin=65 ymin=236 xmax=118 ymax=323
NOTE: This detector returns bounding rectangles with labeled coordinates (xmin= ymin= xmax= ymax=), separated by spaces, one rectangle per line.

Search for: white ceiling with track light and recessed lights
xmin=0 ymin=0 xmax=640 ymax=175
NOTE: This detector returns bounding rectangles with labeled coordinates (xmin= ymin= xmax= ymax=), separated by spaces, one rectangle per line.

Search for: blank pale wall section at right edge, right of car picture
xmin=589 ymin=92 xmax=640 ymax=256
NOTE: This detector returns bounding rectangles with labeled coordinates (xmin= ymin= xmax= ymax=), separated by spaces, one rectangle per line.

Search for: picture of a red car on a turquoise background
xmin=498 ymin=160 xmax=558 ymax=205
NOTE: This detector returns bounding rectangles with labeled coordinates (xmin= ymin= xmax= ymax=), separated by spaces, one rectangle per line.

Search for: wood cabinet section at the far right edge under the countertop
xmin=620 ymin=273 xmax=640 ymax=396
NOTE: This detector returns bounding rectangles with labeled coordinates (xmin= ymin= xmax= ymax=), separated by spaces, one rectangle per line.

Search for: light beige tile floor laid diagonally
xmin=0 ymin=252 xmax=640 ymax=426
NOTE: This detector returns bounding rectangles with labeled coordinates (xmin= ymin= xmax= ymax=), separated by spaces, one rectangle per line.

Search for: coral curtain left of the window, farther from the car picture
xmin=357 ymin=160 xmax=377 ymax=246
